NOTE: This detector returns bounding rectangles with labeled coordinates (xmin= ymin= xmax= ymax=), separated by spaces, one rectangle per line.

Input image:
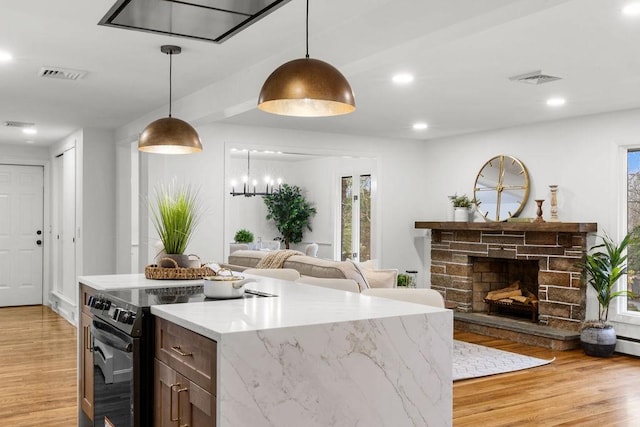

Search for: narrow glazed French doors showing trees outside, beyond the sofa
xmin=340 ymin=174 xmax=372 ymax=262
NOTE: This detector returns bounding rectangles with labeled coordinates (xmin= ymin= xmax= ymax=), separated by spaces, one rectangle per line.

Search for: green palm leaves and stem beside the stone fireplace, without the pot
xmin=582 ymin=233 xmax=635 ymax=325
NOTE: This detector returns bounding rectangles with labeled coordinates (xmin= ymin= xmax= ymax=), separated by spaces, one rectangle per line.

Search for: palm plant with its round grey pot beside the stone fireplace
xmin=580 ymin=233 xmax=634 ymax=357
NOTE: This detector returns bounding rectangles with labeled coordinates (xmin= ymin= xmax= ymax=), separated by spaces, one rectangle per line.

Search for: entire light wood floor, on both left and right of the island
xmin=0 ymin=306 xmax=640 ymax=427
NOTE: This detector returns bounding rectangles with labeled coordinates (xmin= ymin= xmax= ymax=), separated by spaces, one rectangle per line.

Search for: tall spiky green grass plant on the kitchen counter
xmin=150 ymin=181 xmax=201 ymax=267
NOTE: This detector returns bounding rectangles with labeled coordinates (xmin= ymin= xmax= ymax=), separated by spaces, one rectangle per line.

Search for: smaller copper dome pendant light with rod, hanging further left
xmin=138 ymin=45 xmax=202 ymax=154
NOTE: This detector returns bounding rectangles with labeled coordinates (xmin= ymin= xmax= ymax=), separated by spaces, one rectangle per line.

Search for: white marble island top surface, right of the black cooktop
xmin=151 ymin=277 xmax=451 ymax=341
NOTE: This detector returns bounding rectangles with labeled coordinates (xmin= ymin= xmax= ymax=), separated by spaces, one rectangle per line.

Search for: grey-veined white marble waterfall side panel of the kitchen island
xmin=218 ymin=312 xmax=453 ymax=427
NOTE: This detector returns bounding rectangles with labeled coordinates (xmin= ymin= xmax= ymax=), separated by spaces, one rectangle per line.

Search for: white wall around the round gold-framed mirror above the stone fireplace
xmin=422 ymin=110 xmax=640 ymax=317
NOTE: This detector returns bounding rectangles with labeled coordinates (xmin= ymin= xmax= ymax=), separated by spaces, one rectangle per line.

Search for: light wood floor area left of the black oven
xmin=0 ymin=306 xmax=77 ymax=427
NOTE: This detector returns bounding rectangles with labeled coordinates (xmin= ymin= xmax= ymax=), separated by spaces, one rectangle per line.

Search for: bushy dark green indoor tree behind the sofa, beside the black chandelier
xmin=263 ymin=184 xmax=316 ymax=249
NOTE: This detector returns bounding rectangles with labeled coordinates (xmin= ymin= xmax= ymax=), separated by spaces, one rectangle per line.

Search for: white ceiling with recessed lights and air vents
xmin=0 ymin=0 xmax=640 ymax=145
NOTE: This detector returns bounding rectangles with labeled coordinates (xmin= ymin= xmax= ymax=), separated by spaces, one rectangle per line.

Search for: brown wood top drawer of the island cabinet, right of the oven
xmin=155 ymin=318 xmax=217 ymax=395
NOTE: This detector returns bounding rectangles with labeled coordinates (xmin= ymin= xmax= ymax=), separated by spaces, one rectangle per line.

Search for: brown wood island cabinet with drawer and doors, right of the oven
xmin=154 ymin=319 xmax=217 ymax=427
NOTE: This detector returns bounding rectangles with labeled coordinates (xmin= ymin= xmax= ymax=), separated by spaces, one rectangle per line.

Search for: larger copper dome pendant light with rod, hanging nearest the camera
xmin=258 ymin=0 xmax=356 ymax=117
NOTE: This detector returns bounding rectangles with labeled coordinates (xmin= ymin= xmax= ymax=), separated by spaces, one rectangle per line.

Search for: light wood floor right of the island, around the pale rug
xmin=453 ymin=332 xmax=640 ymax=427
